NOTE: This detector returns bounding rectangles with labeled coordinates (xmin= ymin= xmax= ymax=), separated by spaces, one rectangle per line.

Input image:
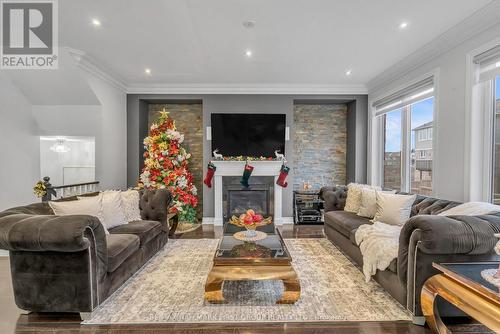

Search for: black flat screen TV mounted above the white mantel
xmin=211 ymin=113 xmax=286 ymax=157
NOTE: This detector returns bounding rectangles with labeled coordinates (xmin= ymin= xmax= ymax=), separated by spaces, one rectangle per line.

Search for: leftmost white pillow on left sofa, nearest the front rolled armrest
xmin=49 ymin=194 xmax=109 ymax=234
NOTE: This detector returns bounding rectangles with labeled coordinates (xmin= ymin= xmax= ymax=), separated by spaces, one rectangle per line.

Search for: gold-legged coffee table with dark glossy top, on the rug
xmin=205 ymin=230 xmax=300 ymax=304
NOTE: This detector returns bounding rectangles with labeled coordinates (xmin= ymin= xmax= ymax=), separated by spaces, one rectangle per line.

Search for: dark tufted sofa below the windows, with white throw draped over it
xmin=320 ymin=186 xmax=500 ymax=324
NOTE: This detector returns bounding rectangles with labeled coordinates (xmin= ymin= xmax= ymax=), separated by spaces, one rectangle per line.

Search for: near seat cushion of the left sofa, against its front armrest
xmin=106 ymin=234 xmax=140 ymax=273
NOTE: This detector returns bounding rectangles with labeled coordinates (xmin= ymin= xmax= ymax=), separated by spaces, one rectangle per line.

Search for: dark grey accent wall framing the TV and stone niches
xmin=127 ymin=94 xmax=368 ymax=217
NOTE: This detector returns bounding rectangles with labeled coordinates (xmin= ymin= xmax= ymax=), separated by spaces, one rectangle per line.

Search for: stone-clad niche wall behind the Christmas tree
xmin=148 ymin=104 xmax=203 ymax=221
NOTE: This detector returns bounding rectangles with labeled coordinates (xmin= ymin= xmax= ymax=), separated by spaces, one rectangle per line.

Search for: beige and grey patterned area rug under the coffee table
xmin=83 ymin=239 xmax=410 ymax=324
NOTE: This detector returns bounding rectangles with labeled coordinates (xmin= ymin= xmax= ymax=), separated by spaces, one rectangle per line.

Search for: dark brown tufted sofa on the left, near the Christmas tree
xmin=0 ymin=189 xmax=172 ymax=318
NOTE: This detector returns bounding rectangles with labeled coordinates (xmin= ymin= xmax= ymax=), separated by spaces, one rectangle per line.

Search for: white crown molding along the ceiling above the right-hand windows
xmin=366 ymin=0 xmax=500 ymax=94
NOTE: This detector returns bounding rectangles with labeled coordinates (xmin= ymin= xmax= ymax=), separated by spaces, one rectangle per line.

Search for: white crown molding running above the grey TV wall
xmin=127 ymin=84 xmax=368 ymax=95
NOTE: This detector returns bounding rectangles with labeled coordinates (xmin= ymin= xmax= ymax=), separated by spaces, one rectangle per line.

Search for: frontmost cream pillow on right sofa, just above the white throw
xmin=373 ymin=191 xmax=417 ymax=225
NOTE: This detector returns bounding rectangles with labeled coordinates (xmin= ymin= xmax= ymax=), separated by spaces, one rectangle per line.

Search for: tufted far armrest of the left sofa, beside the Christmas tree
xmin=139 ymin=189 xmax=172 ymax=232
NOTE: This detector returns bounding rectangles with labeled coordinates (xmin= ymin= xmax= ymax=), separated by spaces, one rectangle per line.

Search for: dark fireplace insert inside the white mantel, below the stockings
xmin=222 ymin=176 xmax=274 ymax=221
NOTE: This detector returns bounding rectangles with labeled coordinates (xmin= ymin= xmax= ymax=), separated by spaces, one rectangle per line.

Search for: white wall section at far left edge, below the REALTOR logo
xmin=0 ymin=75 xmax=40 ymax=211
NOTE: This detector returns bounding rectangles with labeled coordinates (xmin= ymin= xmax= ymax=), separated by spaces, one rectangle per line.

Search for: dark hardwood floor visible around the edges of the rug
xmin=0 ymin=225 xmax=491 ymax=334
